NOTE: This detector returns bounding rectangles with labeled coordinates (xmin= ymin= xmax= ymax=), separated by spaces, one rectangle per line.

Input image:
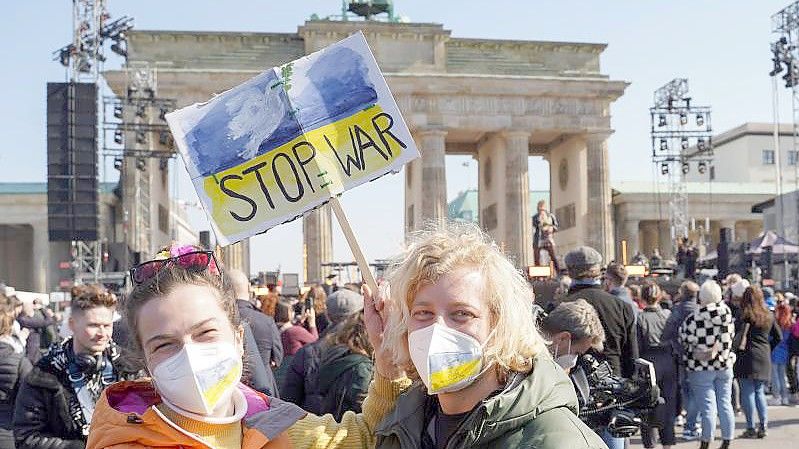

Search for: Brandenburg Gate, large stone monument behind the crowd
xmin=105 ymin=20 xmax=627 ymax=281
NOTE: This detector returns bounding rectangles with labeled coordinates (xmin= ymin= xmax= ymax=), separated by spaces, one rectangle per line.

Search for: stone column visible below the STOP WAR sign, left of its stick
xmin=302 ymin=204 xmax=333 ymax=282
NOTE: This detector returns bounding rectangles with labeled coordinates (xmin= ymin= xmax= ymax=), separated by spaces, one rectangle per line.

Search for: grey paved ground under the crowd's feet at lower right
xmin=630 ymin=406 xmax=799 ymax=449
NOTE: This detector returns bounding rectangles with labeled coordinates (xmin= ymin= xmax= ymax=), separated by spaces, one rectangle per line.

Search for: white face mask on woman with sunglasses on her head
xmin=152 ymin=342 xmax=242 ymax=416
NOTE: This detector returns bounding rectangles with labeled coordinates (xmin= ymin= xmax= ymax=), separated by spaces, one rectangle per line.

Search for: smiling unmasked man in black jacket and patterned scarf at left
xmin=14 ymin=285 xmax=120 ymax=449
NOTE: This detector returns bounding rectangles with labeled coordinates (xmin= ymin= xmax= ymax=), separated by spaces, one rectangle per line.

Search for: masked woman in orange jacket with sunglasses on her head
xmin=87 ymin=245 xmax=408 ymax=449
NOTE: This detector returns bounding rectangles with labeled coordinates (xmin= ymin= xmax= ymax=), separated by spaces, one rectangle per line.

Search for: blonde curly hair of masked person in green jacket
xmin=383 ymin=222 xmax=548 ymax=379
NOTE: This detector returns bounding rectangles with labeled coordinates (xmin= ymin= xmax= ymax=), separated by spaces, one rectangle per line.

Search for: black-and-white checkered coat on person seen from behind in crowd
xmin=680 ymin=301 xmax=735 ymax=371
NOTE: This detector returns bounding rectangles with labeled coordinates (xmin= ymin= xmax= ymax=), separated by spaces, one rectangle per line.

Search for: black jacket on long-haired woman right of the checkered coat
xmin=733 ymin=317 xmax=782 ymax=381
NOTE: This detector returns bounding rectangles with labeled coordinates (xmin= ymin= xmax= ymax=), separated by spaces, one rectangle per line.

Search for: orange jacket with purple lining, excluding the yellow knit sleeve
xmin=86 ymin=380 xmax=306 ymax=449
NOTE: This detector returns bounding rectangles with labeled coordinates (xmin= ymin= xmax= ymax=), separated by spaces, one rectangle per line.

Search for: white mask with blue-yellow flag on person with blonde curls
xmin=408 ymin=323 xmax=483 ymax=394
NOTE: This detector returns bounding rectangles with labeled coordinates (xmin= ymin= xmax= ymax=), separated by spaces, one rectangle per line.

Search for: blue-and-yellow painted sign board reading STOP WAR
xmin=166 ymin=32 xmax=419 ymax=245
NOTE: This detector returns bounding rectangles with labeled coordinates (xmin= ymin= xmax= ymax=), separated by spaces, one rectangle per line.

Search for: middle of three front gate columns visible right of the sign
xmin=504 ymin=131 xmax=533 ymax=268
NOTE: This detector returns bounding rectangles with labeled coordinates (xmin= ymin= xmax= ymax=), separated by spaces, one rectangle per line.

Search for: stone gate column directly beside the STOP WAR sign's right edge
xmin=414 ymin=129 xmax=447 ymax=224
